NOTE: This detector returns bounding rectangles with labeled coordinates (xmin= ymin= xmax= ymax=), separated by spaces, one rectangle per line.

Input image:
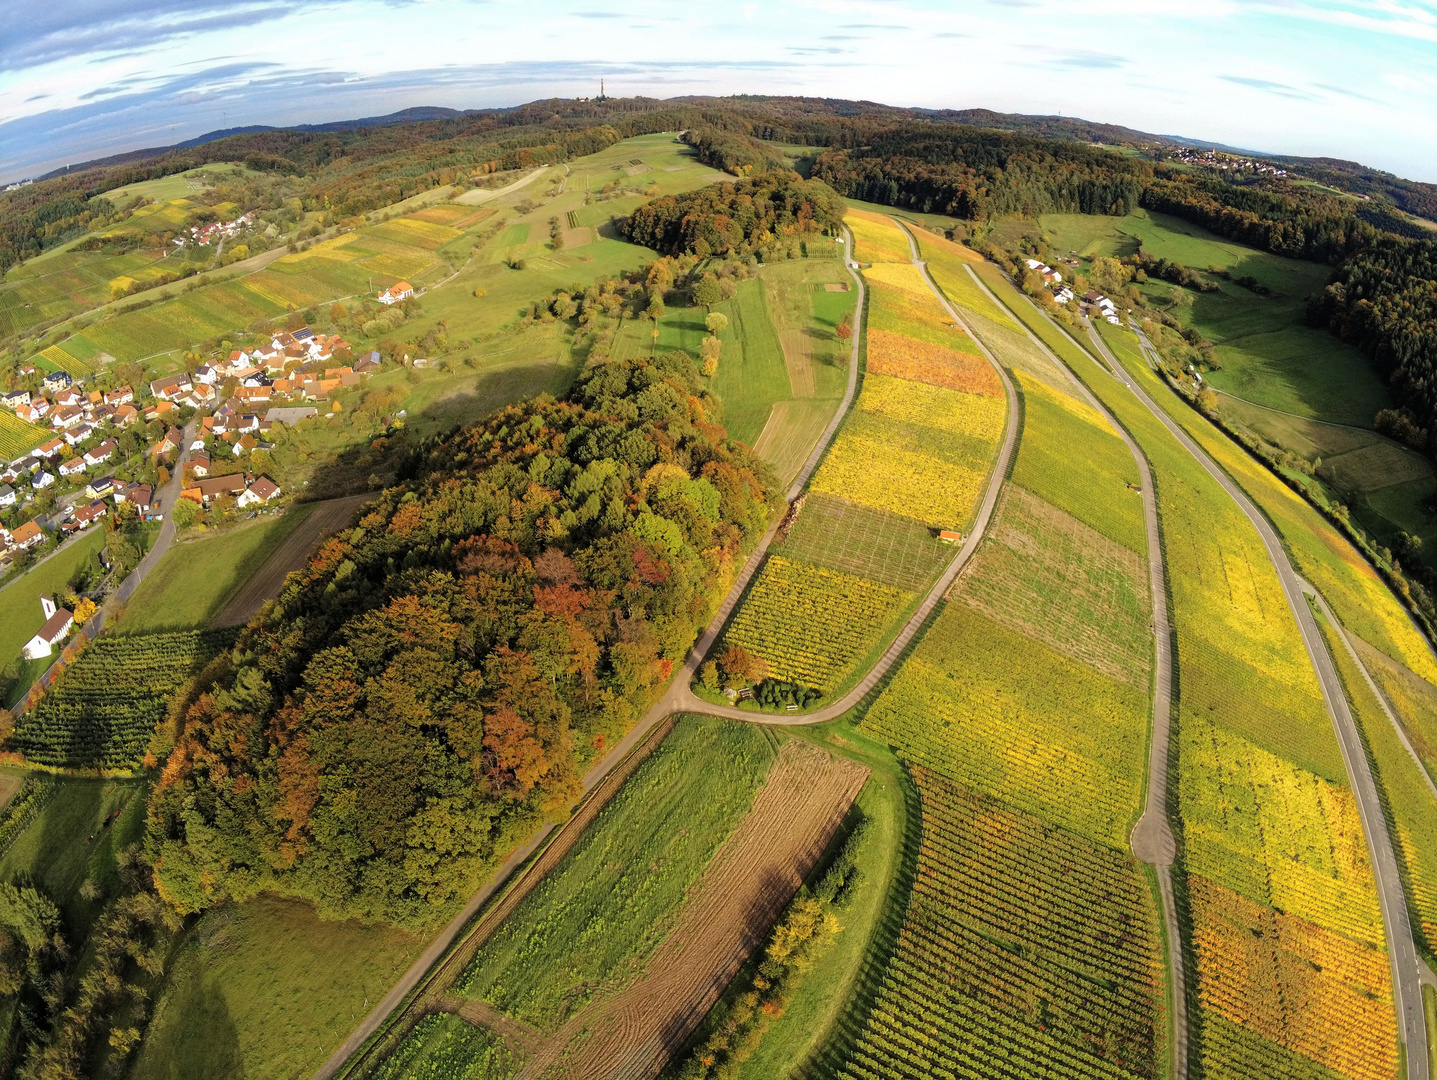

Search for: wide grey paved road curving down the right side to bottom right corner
xmin=1088 ymin=318 xmax=1430 ymax=1080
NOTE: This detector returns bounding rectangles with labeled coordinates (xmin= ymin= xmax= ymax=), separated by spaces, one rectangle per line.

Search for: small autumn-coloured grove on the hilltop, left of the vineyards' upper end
xmin=624 ymin=169 xmax=844 ymax=257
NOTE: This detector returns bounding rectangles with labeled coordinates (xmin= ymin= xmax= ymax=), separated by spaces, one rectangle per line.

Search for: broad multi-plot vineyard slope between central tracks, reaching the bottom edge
xmin=842 ymin=350 xmax=1167 ymax=1080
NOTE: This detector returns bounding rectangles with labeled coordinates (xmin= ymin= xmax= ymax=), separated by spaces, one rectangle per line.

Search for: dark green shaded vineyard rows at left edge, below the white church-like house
xmin=9 ymin=630 xmax=234 ymax=770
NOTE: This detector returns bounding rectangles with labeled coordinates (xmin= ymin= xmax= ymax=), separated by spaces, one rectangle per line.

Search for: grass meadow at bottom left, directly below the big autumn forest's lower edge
xmin=128 ymin=896 xmax=424 ymax=1080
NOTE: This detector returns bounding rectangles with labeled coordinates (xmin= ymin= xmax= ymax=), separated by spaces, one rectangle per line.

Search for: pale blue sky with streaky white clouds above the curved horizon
xmin=0 ymin=0 xmax=1437 ymax=182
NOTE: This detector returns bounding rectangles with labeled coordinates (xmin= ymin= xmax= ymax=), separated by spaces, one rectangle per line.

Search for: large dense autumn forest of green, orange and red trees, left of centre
xmin=148 ymin=353 xmax=770 ymax=928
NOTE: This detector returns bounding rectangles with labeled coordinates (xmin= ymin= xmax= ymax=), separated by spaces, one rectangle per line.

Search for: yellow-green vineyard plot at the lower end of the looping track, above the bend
xmin=720 ymin=554 xmax=912 ymax=692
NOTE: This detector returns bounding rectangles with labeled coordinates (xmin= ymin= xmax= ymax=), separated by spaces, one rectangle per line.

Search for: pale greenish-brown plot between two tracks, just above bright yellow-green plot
xmin=950 ymin=485 xmax=1152 ymax=689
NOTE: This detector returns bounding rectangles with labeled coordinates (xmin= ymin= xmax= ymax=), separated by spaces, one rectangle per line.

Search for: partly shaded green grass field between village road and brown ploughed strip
xmin=118 ymin=506 xmax=313 ymax=633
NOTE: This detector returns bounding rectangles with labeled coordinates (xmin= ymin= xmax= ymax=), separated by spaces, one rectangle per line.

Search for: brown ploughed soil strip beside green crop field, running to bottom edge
xmin=519 ymin=741 xmax=868 ymax=1080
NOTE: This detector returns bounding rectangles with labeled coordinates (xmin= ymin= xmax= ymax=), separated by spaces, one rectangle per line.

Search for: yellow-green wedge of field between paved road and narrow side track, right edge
xmin=1318 ymin=615 xmax=1437 ymax=954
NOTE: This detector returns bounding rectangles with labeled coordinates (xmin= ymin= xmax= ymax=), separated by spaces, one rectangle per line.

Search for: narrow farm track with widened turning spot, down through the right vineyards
xmin=964 ymin=267 xmax=1188 ymax=1080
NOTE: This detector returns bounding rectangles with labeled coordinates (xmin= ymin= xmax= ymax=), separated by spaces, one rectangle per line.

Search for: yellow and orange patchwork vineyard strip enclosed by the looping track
xmin=709 ymin=213 xmax=1007 ymax=695
